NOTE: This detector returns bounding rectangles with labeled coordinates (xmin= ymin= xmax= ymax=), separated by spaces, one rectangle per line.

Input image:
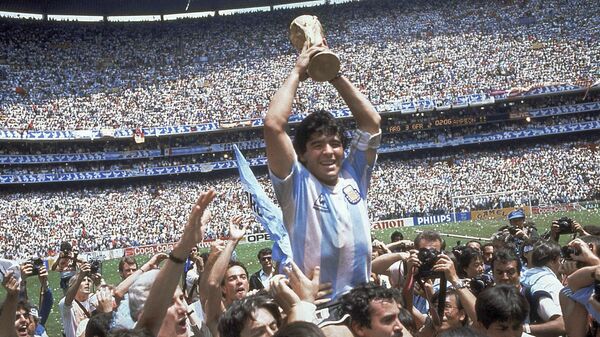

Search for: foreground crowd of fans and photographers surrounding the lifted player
xmin=0 ymin=197 xmax=600 ymax=337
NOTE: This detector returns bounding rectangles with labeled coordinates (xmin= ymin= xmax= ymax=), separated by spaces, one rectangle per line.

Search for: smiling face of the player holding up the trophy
xmin=299 ymin=133 xmax=344 ymax=186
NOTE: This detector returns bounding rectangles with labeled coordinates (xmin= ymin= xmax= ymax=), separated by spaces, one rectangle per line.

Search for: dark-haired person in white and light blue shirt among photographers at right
xmin=521 ymin=241 xmax=565 ymax=336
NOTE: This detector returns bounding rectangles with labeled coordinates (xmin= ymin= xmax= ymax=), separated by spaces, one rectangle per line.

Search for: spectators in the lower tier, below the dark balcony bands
xmin=0 ymin=138 xmax=600 ymax=258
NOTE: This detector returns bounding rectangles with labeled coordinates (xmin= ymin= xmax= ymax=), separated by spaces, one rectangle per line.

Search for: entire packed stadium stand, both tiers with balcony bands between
xmin=0 ymin=0 xmax=600 ymax=258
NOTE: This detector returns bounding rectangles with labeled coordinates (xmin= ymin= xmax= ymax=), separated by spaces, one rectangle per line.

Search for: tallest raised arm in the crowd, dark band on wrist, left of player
xmin=137 ymin=190 xmax=215 ymax=336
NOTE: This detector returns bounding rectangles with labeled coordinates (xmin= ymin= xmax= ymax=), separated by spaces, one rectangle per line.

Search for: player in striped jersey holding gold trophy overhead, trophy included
xmin=264 ymin=15 xmax=381 ymax=332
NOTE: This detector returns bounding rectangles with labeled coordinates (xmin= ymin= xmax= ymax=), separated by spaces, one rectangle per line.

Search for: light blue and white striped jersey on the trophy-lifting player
xmin=271 ymin=140 xmax=372 ymax=298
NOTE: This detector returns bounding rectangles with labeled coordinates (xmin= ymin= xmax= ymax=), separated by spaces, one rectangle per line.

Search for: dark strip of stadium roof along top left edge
xmin=0 ymin=0 xmax=318 ymax=16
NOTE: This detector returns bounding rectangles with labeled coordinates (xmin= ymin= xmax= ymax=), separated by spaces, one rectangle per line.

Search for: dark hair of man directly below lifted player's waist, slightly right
xmin=341 ymin=282 xmax=397 ymax=328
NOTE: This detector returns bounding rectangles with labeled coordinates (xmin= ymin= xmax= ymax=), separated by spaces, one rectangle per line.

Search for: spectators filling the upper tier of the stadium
xmin=0 ymin=0 xmax=600 ymax=130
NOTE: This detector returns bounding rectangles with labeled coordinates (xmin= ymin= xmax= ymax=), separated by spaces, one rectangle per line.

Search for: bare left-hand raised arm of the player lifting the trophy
xmin=264 ymin=44 xmax=325 ymax=179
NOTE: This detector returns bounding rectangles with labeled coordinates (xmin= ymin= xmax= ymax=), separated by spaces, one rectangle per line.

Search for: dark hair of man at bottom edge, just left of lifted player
xmin=218 ymin=292 xmax=281 ymax=337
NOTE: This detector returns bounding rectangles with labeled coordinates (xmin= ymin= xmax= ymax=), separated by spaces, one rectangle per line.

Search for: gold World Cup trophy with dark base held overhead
xmin=290 ymin=15 xmax=340 ymax=82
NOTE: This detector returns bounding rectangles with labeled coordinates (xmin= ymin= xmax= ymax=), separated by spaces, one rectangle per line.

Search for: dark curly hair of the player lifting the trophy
xmin=294 ymin=110 xmax=346 ymax=155
